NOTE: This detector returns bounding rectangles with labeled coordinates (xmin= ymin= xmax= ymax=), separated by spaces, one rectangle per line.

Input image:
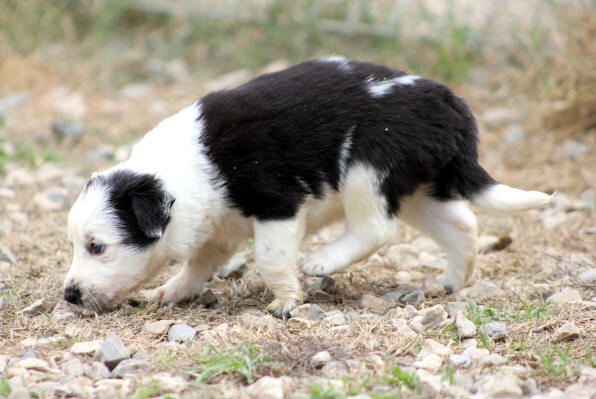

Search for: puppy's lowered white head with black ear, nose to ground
xmin=64 ymin=169 xmax=174 ymax=311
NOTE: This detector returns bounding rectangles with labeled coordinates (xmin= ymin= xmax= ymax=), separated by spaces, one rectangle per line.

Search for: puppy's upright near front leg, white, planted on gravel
xmin=254 ymin=212 xmax=305 ymax=318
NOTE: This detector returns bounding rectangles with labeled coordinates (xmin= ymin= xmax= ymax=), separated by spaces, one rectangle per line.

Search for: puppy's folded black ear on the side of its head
xmin=130 ymin=188 xmax=176 ymax=238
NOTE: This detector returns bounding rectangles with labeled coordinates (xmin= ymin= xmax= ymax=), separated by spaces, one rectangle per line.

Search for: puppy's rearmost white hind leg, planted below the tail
xmin=399 ymin=189 xmax=477 ymax=293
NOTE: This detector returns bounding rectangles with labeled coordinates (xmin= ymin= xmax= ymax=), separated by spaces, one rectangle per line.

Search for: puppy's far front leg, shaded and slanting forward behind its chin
xmin=148 ymin=242 xmax=236 ymax=303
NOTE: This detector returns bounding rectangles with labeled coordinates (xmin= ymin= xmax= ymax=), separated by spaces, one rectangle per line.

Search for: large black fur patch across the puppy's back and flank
xmin=199 ymin=60 xmax=492 ymax=220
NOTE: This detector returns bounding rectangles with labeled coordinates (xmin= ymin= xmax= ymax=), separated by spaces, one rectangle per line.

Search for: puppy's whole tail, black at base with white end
xmin=437 ymin=159 xmax=553 ymax=213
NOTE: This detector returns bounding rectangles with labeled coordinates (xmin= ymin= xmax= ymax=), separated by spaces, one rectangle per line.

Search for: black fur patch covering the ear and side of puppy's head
xmin=85 ymin=169 xmax=174 ymax=249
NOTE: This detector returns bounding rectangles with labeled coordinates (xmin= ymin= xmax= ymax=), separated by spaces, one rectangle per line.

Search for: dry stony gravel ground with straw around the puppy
xmin=0 ymin=54 xmax=596 ymax=399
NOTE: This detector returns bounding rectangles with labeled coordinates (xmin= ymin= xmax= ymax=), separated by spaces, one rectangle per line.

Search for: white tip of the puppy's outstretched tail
xmin=470 ymin=184 xmax=553 ymax=212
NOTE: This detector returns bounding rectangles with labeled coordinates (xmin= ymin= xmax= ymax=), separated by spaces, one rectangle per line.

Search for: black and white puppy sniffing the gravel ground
xmin=64 ymin=57 xmax=551 ymax=317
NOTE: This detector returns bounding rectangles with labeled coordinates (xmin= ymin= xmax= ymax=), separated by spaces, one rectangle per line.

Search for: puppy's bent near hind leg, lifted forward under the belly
xmin=302 ymin=165 xmax=397 ymax=276
